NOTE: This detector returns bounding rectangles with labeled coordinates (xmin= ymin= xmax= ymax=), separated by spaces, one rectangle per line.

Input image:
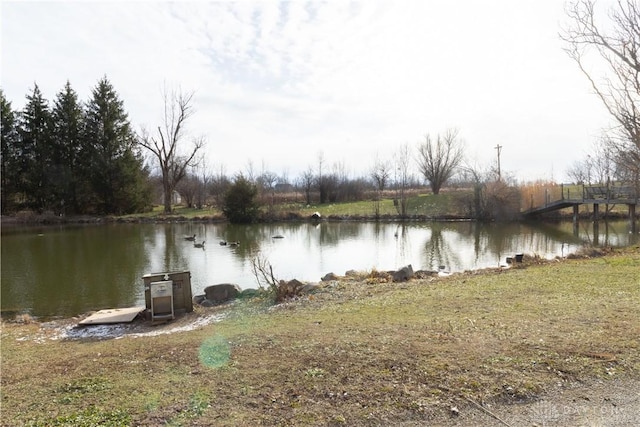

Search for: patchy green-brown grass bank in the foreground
xmin=1 ymin=247 xmax=640 ymax=426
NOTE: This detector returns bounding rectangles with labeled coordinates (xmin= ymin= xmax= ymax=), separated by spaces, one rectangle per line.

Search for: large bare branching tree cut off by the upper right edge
xmin=560 ymin=0 xmax=640 ymax=185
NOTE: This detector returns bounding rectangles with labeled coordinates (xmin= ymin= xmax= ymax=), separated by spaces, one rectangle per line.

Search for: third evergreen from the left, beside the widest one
xmin=51 ymin=81 xmax=86 ymax=213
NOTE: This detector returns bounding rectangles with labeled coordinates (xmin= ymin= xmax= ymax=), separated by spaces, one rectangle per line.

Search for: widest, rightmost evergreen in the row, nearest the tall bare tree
xmin=80 ymin=77 xmax=151 ymax=214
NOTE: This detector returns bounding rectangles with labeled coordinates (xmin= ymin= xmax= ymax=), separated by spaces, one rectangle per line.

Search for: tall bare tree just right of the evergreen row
xmin=138 ymin=88 xmax=204 ymax=214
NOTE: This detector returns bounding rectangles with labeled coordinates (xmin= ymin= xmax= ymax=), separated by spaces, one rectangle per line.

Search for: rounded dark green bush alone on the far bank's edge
xmin=222 ymin=175 xmax=260 ymax=224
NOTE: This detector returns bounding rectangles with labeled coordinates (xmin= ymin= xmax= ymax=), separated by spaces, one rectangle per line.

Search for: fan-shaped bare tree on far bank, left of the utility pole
xmin=418 ymin=129 xmax=463 ymax=194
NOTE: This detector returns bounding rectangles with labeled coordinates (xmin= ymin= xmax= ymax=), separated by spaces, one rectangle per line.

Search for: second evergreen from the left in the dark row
xmin=17 ymin=84 xmax=53 ymax=212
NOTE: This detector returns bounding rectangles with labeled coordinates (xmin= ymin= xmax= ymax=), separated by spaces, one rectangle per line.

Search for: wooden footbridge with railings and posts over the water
xmin=522 ymin=184 xmax=639 ymax=223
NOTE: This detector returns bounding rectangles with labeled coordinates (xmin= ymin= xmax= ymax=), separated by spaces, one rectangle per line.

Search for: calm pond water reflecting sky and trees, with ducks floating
xmin=1 ymin=221 xmax=640 ymax=318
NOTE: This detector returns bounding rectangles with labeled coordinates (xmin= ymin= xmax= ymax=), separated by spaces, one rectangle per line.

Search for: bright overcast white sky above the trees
xmin=0 ymin=0 xmax=612 ymax=182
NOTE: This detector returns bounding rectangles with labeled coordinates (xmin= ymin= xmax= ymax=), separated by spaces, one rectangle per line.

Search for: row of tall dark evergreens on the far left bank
xmin=0 ymin=77 xmax=152 ymax=215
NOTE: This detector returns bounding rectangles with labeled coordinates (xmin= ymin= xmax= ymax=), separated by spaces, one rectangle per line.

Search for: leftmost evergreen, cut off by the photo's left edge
xmin=0 ymin=89 xmax=18 ymax=214
